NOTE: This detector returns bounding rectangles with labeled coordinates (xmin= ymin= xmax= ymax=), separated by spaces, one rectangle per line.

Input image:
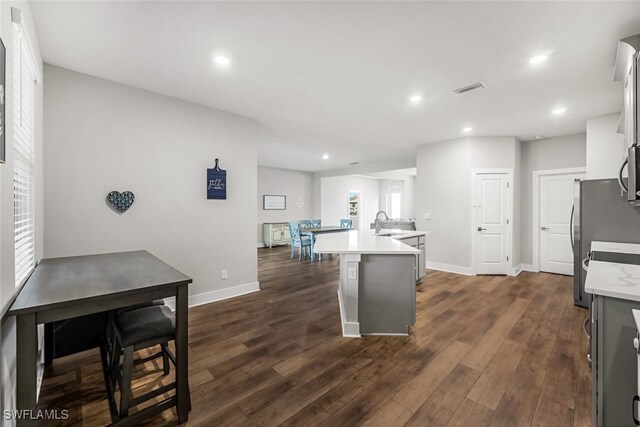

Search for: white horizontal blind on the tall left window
xmin=13 ymin=25 xmax=36 ymax=286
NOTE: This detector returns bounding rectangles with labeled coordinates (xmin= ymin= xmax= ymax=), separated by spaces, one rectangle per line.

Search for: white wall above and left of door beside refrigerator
xmin=520 ymin=133 xmax=587 ymax=264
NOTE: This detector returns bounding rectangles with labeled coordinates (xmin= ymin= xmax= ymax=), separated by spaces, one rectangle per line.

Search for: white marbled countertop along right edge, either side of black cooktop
xmin=584 ymin=242 xmax=640 ymax=301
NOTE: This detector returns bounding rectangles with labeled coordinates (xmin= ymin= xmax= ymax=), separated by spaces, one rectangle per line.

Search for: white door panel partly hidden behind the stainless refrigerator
xmin=534 ymin=174 xmax=584 ymax=275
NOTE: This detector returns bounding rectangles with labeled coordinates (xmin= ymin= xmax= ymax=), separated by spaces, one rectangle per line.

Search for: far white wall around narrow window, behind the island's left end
xmin=320 ymin=175 xmax=380 ymax=230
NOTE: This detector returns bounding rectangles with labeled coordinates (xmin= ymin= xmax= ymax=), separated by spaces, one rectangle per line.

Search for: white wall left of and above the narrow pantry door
xmin=415 ymin=137 xmax=519 ymax=272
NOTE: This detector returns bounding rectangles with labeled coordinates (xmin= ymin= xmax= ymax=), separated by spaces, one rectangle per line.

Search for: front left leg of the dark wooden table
xmin=16 ymin=313 xmax=38 ymax=427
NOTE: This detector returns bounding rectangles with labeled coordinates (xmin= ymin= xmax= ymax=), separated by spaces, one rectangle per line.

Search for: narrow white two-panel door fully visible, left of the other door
xmin=475 ymin=173 xmax=509 ymax=274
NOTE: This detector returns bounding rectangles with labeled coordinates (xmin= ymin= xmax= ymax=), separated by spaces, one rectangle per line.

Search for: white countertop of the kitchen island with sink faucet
xmin=313 ymin=230 xmax=426 ymax=254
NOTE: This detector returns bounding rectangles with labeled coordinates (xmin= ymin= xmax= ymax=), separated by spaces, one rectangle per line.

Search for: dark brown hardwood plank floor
xmin=39 ymin=248 xmax=591 ymax=427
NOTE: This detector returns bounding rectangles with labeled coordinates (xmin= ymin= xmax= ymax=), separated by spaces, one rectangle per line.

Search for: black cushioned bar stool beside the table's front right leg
xmin=102 ymin=305 xmax=185 ymax=423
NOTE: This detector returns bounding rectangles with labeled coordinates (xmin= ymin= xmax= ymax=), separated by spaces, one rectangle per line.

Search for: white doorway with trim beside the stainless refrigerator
xmin=532 ymin=169 xmax=585 ymax=276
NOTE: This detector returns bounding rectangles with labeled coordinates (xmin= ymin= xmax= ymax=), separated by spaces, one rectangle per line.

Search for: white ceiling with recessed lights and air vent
xmin=31 ymin=1 xmax=640 ymax=171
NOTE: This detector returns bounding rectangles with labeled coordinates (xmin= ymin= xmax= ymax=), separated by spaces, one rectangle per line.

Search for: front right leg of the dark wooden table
xmin=176 ymin=285 xmax=190 ymax=424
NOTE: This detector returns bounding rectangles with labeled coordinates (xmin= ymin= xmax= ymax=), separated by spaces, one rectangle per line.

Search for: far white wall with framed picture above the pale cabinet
xmin=257 ymin=166 xmax=319 ymax=246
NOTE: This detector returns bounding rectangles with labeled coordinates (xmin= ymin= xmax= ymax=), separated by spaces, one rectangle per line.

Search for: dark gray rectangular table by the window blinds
xmin=7 ymin=250 xmax=193 ymax=426
